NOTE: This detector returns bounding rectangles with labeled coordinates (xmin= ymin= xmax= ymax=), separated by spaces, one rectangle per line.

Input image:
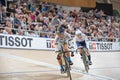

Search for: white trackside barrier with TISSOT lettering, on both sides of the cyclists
xmin=0 ymin=34 xmax=120 ymax=51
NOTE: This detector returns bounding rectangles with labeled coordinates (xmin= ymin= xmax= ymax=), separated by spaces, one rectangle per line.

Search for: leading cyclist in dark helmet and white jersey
xmin=55 ymin=25 xmax=73 ymax=73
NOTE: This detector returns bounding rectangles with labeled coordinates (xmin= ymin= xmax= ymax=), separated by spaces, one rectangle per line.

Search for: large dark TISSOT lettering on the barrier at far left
xmin=0 ymin=35 xmax=33 ymax=47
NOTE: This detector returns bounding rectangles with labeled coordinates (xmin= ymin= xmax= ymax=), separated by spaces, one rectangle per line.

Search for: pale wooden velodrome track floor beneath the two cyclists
xmin=0 ymin=48 xmax=120 ymax=80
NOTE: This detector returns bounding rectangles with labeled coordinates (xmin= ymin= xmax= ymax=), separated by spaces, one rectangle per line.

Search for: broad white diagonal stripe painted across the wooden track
xmin=0 ymin=53 xmax=114 ymax=80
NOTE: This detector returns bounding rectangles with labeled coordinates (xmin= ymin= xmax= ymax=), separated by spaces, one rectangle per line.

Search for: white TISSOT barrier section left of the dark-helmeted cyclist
xmin=0 ymin=34 xmax=54 ymax=50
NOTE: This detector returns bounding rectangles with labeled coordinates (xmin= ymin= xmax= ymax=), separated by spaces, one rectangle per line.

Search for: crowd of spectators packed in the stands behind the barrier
xmin=0 ymin=2 xmax=120 ymax=41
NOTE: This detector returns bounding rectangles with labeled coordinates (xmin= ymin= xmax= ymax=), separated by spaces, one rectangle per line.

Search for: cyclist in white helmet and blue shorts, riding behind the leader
xmin=75 ymin=30 xmax=92 ymax=65
